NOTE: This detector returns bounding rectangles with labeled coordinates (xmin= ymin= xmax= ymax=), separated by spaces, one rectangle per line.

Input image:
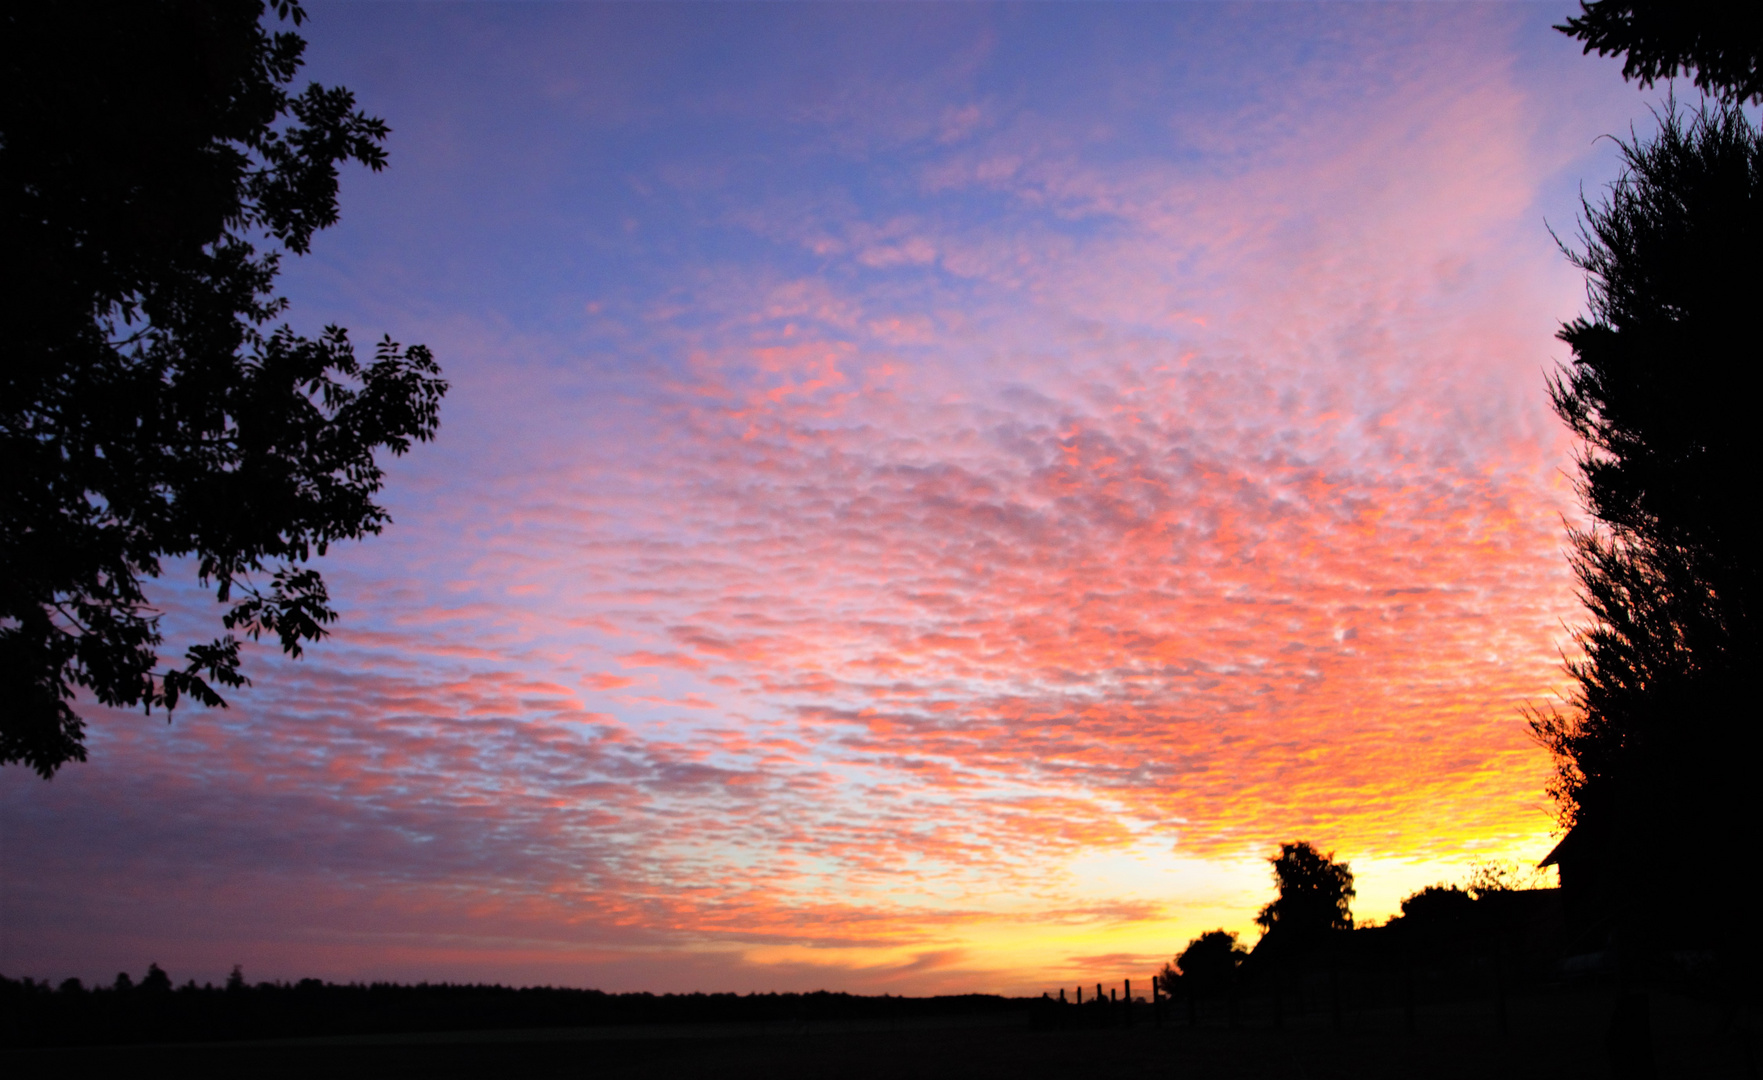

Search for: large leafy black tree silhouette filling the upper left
xmin=0 ymin=0 xmax=446 ymax=777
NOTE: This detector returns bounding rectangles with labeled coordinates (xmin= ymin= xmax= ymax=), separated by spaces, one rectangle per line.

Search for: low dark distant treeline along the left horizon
xmin=0 ymin=965 xmax=1028 ymax=1047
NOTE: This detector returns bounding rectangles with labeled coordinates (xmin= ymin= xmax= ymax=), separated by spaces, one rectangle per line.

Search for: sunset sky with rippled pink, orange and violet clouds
xmin=0 ymin=2 xmax=1664 ymax=994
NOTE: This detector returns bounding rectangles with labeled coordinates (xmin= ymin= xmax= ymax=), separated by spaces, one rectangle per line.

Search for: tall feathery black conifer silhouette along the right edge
xmin=1532 ymin=106 xmax=1763 ymax=941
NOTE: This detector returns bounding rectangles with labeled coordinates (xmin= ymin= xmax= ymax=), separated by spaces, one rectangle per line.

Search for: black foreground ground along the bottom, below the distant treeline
xmin=0 ymin=990 xmax=1763 ymax=1080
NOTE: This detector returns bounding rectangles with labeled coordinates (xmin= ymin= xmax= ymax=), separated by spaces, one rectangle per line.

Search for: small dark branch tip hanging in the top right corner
xmin=1555 ymin=0 xmax=1763 ymax=102
